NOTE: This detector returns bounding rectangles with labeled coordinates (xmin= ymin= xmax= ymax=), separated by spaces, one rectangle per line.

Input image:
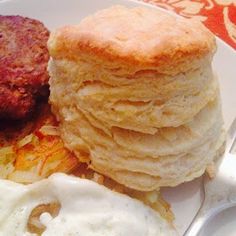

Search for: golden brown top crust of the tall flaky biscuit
xmin=48 ymin=6 xmax=215 ymax=71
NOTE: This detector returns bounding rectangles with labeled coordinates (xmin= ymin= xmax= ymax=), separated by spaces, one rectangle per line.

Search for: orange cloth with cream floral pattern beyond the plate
xmin=143 ymin=0 xmax=236 ymax=49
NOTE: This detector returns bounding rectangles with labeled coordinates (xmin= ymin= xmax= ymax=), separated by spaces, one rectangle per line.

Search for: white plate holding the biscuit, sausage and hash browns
xmin=0 ymin=0 xmax=236 ymax=235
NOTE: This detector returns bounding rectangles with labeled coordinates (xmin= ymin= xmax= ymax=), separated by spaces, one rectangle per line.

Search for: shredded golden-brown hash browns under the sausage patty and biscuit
xmin=0 ymin=103 xmax=174 ymax=225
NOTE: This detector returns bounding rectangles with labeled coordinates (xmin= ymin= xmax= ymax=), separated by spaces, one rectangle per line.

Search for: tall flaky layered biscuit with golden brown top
xmin=48 ymin=6 xmax=224 ymax=191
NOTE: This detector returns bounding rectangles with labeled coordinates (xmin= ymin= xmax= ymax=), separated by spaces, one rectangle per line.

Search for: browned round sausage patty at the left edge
xmin=0 ymin=16 xmax=49 ymax=119
